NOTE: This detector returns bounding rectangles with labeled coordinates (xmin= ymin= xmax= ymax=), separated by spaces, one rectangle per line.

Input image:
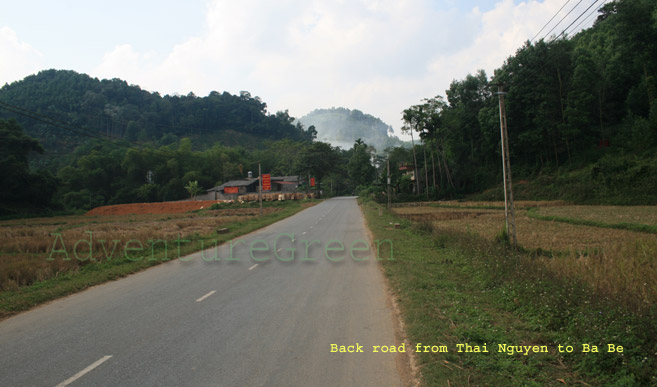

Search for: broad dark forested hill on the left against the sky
xmin=0 ymin=70 xmax=306 ymax=169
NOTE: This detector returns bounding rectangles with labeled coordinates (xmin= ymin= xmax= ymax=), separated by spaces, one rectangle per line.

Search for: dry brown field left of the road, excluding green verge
xmin=0 ymin=208 xmax=281 ymax=291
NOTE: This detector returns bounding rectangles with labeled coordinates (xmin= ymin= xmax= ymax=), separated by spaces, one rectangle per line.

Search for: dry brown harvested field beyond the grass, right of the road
xmin=393 ymin=202 xmax=657 ymax=307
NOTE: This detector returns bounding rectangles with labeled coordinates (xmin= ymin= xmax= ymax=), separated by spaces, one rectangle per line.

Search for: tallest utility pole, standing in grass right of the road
xmin=493 ymin=83 xmax=518 ymax=247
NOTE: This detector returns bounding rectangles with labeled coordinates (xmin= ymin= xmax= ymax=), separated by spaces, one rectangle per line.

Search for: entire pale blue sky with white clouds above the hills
xmin=0 ymin=0 xmax=597 ymax=138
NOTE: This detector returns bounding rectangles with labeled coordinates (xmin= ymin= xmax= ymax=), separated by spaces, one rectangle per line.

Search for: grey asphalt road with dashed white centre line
xmin=0 ymin=198 xmax=402 ymax=386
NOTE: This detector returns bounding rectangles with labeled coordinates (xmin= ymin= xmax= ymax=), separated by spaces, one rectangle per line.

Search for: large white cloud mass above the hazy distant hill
xmin=89 ymin=0 xmax=562 ymax=139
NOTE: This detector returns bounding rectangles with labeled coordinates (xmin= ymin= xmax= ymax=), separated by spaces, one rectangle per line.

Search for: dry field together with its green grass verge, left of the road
xmin=0 ymin=201 xmax=316 ymax=318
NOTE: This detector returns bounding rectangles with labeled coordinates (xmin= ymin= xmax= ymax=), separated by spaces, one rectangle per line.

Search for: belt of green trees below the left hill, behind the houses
xmin=0 ymin=112 xmax=374 ymax=217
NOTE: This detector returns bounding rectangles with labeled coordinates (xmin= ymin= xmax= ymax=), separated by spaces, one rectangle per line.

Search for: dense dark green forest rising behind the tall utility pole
xmin=397 ymin=0 xmax=657 ymax=204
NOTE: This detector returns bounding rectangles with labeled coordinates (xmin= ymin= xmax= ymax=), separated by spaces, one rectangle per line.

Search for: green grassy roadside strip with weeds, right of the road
xmin=363 ymin=203 xmax=657 ymax=386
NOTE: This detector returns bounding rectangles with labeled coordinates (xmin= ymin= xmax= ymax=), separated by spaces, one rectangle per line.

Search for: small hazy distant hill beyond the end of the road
xmin=299 ymin=108 xmax=403 ymax=152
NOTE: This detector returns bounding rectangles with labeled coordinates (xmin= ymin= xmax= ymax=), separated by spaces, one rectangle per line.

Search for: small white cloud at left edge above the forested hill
xmin=0 ymin=27 xmax=42 ymax=87
